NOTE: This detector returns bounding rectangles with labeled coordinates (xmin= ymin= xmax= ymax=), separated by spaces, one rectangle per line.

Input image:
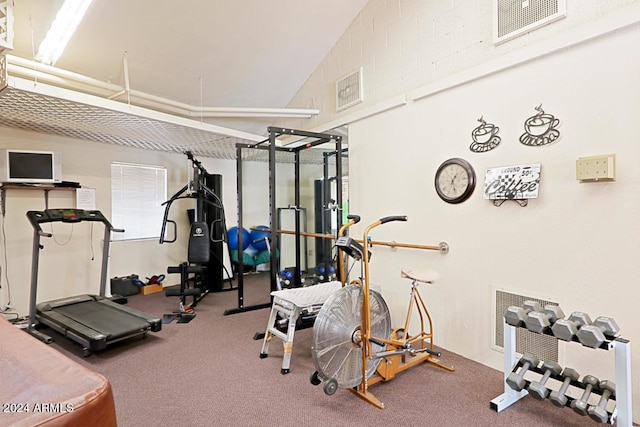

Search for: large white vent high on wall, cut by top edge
xmin=493 ymin=0 xmax=567 ymax=44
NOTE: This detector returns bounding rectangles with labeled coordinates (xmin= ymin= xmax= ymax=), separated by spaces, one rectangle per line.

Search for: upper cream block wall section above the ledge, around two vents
xmin=278 ymin=0 xmax=638 ymax=131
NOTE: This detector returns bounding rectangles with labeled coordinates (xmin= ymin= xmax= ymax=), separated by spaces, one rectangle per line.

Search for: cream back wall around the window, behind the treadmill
xmin=0 ymin=128 xmax=237 ymax=315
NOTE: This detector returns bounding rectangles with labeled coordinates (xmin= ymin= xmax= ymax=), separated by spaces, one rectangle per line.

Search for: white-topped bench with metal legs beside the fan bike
xmin=260 ymin=281 xmax=342 ymax=375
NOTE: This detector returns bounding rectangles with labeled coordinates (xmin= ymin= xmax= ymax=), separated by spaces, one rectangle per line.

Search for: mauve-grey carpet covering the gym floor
xmin=42 ymin=275 xmax=612 ymax=427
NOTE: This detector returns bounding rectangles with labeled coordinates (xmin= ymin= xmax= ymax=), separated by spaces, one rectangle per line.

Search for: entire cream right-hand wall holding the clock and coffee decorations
xmin=283 ymin=0 xmax=640 ymax=421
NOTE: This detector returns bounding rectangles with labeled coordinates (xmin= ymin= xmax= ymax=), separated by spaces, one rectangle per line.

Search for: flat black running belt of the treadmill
xmin=55 ymin=301 xmax=149 ymax=340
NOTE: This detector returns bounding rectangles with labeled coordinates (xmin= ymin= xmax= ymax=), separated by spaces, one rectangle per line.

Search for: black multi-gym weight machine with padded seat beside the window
xmin=160 ymin=151 xmax=233 ymax=323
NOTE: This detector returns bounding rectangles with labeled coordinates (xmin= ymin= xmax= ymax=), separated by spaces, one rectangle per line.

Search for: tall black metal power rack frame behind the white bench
xmin=224 ymin=126 xmax=343 ymax=315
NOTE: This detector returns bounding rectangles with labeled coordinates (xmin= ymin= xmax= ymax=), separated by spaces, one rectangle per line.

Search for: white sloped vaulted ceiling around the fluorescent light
xmin=0 ymin=0 xmax=367 ymax=157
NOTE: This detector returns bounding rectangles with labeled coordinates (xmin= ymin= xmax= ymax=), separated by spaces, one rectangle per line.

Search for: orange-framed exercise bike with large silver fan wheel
xmin=310 ymin=216 xmax=455 ymax=409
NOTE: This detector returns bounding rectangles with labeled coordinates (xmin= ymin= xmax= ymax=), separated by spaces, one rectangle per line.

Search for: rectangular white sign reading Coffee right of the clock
xmin=484 ymin=163 xmax=540 ymax=200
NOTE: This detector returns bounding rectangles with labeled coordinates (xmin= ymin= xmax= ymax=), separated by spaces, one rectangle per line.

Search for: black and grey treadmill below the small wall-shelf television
xmin=27 ymin=209 xmax=162 ymax=357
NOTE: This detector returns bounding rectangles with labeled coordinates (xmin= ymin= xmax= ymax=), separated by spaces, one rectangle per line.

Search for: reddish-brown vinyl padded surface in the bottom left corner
xmin=0 ymin=316 xmax=116 ymax=427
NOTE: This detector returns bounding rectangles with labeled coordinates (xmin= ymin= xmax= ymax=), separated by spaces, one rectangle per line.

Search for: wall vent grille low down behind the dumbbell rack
xmin=495 ymin=290 xmax=558 ymax=362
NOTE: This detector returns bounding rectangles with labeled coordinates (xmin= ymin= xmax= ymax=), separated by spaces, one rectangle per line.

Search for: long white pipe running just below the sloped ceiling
xmin=6 ymin=55 xmax=320 ymax=118
